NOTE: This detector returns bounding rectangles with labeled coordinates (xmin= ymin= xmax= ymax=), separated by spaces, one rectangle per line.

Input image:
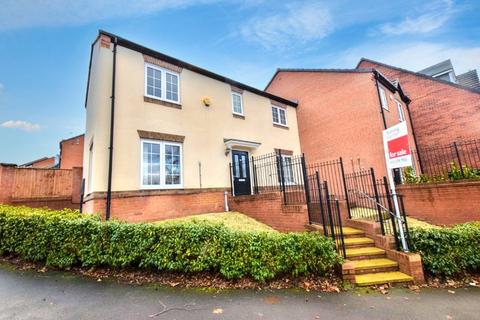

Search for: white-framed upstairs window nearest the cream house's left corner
xmin=145 ymin=63 xmax=180 ymax=103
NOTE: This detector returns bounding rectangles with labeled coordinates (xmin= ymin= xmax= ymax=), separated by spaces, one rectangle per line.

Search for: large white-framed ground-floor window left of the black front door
xmin=140 ymin=139 xmax=183 ymax=189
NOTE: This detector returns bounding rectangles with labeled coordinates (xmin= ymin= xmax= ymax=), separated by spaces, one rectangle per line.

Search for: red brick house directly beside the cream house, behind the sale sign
xmin=266 ymin=68 xmax=415 ymax=179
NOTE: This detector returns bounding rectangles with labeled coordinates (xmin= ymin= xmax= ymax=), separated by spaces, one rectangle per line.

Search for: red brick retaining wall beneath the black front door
xmin=228 ymin=192 xmax=308 ymax=231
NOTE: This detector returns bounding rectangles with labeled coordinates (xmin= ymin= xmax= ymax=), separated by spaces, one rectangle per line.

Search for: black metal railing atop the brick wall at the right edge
xmin=412 ymin=139 xmax=480 ymax=178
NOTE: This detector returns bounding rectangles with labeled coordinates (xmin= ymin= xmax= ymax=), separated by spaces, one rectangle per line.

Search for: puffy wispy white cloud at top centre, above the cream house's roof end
xmin=241 ymin=2 xmax=333 ymax=49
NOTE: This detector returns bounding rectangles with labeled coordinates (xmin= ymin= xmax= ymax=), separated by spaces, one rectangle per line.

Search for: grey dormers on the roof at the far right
xmin=418 ymin=59 xmax=480 ymax=89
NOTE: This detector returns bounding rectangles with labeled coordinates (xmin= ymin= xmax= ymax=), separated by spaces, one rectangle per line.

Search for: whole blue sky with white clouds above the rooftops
xmin=0 ymin=0 xmax=480 ymax=164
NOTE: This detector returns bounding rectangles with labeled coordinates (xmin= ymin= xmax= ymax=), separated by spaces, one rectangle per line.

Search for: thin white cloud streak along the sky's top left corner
xmin=0 ymin=0 xmax=221 ymax=30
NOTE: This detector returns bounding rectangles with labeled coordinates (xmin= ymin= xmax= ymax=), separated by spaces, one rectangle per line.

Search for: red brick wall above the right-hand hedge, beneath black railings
xmin=398 ymin=181 xmax=480 ymax=225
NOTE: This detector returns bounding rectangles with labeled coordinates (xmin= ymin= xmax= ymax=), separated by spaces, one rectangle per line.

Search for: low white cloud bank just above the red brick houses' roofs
xmin=335 ymin=42 xmax=480 ymax=74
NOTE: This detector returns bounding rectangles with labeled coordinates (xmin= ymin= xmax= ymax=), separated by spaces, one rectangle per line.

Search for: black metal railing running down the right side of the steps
xmin=345 ymin=168 xmax=410 ymax=249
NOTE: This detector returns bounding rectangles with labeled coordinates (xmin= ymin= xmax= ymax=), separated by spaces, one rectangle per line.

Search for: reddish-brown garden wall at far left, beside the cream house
xmin=0 ymin=164 xmax=82 ymax=209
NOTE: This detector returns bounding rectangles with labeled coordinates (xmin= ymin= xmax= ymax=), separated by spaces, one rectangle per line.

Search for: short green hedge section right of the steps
xmin=410 ymin=222 xmax=480 ymax=276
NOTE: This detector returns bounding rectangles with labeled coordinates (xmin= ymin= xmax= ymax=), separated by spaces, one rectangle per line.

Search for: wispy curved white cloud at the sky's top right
xmin=379 ymin=0 xmax=454 ymax=35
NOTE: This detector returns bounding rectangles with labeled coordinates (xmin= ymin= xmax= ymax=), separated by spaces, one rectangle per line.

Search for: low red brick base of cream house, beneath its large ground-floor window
xmin=83 ymin=189 xmax=225 ymax=222
